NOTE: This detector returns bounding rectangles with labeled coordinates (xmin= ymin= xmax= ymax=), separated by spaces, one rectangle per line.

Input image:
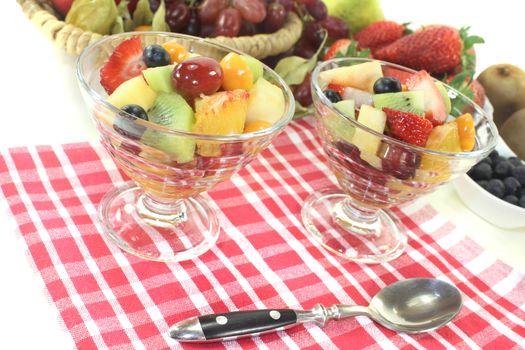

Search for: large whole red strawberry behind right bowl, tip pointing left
xmin=374 ymin=26 xmax=463 ymax=74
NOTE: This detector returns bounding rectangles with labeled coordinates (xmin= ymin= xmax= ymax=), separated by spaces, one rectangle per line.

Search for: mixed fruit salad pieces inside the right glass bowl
xmin=319 ymin=61 xmax=476 ymax=179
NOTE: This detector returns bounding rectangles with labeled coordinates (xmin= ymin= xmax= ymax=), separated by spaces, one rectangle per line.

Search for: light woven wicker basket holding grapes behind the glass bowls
xmin=17 ymin=0 xmax=303 ymax=59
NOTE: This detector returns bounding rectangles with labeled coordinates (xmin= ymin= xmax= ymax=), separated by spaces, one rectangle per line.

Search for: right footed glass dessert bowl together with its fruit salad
xmin=302 ymin=58 xmax=498 ymax=263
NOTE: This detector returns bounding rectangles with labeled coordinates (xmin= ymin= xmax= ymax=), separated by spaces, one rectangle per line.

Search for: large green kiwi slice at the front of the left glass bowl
xmin=141 ymin=93 xmax=195 ymax=163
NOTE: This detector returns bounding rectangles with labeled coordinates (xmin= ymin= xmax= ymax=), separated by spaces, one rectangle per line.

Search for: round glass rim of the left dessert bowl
xmin=76 ymin=31 xmax=295 ymax=142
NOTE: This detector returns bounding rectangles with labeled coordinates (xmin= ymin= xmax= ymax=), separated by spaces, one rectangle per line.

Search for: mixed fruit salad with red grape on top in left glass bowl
xmin=100 ymin=36 xmax=285 ymax=164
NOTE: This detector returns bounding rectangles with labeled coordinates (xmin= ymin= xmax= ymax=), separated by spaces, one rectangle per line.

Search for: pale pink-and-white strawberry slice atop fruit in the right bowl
xmin=405 ymin=70 xmax=448 ymax=126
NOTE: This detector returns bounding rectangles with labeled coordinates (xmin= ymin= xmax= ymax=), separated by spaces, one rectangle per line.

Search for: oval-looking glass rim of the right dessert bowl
xmin=311 ymin=57 xmax=499 ymax=158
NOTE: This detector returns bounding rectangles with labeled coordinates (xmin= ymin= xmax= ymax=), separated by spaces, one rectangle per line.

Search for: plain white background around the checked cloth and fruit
xmin=4 ymin=0 xmax=525 ymax=349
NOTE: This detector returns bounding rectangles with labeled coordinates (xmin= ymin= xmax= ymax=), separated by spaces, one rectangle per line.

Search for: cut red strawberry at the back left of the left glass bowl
xmin=100 ymin=37 xmax=148 ymax=94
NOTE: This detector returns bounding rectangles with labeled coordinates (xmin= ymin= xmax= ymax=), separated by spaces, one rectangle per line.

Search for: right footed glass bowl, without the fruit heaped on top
xmin=302 ymin=58 xmax=498 ymax=263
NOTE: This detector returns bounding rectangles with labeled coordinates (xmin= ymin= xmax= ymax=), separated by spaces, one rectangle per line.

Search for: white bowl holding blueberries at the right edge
xmin=453 ymin=138 xmax=525 ymax=229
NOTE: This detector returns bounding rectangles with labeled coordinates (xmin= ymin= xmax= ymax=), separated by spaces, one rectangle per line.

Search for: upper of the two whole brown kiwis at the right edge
xmin=478 ymin=63 xmax=525 ymax=127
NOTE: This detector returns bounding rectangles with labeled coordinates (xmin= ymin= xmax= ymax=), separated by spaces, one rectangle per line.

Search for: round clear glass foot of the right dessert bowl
xmin=301 ymin=189 xmax=407 ymax=263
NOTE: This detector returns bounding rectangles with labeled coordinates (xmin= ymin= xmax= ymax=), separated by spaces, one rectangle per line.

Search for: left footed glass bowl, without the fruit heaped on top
xmin=77 ymin=32 xmax=294 ymax=262
